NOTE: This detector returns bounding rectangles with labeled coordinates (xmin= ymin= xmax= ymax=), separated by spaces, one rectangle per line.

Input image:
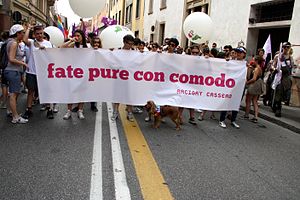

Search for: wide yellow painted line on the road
xmin=119 ymin=105 xmax=174 ymax=200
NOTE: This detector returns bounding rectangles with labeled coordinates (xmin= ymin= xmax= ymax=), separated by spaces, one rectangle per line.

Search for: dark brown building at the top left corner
xmin=0 ymin=0 xmax=55 ymax=31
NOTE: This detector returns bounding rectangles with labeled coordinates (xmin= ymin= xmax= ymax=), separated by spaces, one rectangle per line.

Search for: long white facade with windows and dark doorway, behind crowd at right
xmin=144 ymin=0 xmax=300 ymax=56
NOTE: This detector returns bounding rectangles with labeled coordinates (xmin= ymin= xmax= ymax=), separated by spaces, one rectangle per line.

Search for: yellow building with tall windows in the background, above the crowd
xmin=108 ymin=0 xmax=145 ymax=39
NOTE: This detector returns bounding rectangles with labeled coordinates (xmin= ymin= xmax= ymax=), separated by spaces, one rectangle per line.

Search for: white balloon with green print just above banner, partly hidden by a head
xmin=100 ymin=25 xmax=134 ymax=49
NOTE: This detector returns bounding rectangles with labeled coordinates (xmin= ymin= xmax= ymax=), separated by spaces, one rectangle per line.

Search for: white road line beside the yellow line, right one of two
xmin=107 ymin=103 xmax=131 ymax=200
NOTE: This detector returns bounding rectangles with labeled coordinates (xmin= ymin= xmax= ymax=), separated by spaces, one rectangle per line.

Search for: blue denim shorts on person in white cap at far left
xmin=4 ymin=70 xmax=21 ymax=93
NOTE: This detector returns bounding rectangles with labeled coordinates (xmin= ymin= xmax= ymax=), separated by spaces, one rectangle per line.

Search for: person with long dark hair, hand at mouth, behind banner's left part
xmin=61 ymin=30 xmax=88 ymax=120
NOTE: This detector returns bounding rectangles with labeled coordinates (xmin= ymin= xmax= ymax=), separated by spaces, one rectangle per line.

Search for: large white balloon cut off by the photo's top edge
xmin=69 ymin=0 xmax=106 ymax=18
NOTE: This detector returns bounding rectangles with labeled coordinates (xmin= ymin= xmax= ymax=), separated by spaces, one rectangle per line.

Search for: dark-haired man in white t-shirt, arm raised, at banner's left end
xmin=23 ymin=25 xmax=53 ymax=119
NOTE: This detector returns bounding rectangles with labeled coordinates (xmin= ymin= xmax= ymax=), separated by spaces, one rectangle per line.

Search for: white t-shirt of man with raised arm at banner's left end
xmin=26 ymin=39 xmax=52 ymax=75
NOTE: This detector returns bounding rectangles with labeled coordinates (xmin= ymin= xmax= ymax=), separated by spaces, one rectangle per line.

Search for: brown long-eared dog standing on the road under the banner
xmin=145 ymin=101 xmax=180 ymax=130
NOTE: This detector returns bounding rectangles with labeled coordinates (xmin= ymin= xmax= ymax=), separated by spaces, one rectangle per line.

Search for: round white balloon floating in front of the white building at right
xmin=183 ymin=12 xmax=213 ymax=44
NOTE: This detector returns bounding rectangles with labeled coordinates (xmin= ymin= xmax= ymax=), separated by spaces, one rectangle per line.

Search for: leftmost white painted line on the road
xmin=90 ymin=102 xmax=103 ymax=200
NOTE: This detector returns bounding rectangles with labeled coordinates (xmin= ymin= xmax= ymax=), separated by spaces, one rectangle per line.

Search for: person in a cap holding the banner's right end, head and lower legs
xmin=219 ymin=46 xmax=247 ymax=128
